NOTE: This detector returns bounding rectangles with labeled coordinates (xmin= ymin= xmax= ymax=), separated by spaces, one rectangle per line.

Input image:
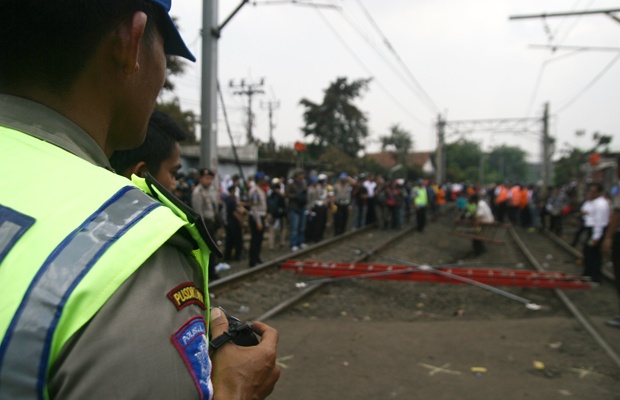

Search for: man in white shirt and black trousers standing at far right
xmin=582 ymin=183 xmax=609 ymax=282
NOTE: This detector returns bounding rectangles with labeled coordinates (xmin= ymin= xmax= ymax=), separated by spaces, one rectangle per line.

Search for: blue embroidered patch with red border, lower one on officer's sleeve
xmin=171 ymin=317 xmax=213 ymax=400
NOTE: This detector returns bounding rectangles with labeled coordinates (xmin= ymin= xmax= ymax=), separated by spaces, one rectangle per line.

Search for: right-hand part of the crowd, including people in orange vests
xmin=451 ymin=179 xmax=620 ymax=328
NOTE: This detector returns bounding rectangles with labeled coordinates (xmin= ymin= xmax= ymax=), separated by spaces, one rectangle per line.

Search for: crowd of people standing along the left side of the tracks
xmin=173 ymin=168 xmax=446 ymax=280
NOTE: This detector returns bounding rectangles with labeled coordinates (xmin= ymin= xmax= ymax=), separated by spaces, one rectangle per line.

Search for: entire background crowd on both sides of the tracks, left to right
xmin=148 ymin=148 xmax=620 ymax=332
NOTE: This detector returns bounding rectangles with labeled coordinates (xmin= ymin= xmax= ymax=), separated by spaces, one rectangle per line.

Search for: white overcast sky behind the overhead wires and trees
xmin=171 ymin=0 xmax=620 ymax=160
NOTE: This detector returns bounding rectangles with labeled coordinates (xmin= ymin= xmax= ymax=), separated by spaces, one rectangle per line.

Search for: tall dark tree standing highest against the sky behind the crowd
xmin=299 ymin=78 xmax=370 ymax=157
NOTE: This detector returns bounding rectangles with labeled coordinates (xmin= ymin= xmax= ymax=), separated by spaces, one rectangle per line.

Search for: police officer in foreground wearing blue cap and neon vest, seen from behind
xmin=0 ymin=0 xmax=279 ymax=399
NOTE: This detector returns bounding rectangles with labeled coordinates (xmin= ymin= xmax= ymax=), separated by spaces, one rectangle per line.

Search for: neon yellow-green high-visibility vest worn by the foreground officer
xmin=0 ymin=127 xmax=211 ymax=399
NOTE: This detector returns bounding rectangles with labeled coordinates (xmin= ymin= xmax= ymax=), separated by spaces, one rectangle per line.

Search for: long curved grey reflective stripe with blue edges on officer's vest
xmin=0 ymin=187 xmax=160 ymax=399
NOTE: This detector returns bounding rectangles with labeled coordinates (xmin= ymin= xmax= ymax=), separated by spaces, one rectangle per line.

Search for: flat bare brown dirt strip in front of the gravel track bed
xmin=270 ymin=318 xmax=620 ymax=400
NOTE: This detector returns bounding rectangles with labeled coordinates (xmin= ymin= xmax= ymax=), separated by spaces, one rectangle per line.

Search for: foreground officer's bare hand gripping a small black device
xmin=211 ymin=308 xmax=280 ymax=400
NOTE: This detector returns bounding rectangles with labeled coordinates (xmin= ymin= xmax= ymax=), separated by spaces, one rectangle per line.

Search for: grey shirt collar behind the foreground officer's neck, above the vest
xmin=0 ymin=94 xmax=112 ymax=170
